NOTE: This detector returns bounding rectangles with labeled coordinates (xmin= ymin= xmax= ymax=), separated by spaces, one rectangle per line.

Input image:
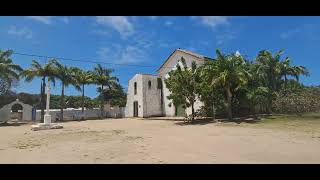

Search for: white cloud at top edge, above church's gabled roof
xmin=191 ymin=16 xmax=229 ymax=28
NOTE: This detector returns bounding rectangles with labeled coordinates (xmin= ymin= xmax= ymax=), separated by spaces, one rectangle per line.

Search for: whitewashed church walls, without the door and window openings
xmin=125 ymin=51 xmax=208 ymax=117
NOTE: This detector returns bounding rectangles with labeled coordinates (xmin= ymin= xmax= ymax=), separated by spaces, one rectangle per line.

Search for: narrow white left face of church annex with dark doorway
xmin=125 ymin=74 xmax=143 ymax=117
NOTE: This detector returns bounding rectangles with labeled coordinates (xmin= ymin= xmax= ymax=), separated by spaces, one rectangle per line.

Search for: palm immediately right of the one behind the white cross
xmin=54 ymin=61 xmax=80 ymax=121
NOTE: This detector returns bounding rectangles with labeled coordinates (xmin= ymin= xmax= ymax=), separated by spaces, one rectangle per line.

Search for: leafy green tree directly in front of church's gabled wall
xmin=165 ymin=57 xmax=200 ymax=121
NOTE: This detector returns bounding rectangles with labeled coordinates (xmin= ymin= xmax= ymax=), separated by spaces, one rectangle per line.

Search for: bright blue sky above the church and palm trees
xmin=0 ymin=16 xmax=320 ymax=97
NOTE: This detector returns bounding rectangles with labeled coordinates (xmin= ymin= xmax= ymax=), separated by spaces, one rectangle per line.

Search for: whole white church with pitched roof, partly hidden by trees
xmin=125 ymin=49 xmax=211 ymax=117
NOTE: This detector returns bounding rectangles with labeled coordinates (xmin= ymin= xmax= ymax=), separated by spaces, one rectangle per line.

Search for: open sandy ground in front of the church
xmin=0 ymin=119 xmax=320 ymax=164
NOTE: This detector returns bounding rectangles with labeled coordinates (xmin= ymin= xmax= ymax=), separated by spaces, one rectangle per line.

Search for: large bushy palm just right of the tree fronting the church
xmin=198 ymin=50 xmax=249 ymax=119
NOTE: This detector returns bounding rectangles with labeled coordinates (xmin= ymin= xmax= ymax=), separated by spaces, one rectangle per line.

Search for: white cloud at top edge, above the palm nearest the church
xmin=96 ymin=16 xmax=134 ymax=37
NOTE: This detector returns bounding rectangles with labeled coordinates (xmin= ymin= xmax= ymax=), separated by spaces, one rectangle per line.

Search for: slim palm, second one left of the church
xmin=72 ymin=68 xmax=93 ymax=114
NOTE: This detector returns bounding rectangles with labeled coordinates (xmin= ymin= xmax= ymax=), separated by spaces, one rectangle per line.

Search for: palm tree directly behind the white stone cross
xmin=21 ymin=60 xmax=56 ymax=122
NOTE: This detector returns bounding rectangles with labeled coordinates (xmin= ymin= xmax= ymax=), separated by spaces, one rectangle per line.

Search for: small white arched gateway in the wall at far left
xmin=0 ymin=99 xmax=32 ymax=122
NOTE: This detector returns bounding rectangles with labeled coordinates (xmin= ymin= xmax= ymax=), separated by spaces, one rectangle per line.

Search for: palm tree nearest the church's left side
xmin=93 ymin=64 xmax=118 ymax=117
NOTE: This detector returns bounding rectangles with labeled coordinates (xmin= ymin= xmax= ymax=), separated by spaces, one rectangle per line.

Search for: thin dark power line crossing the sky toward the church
xmin=13 ymin=52 xmax=174 ymax=68
